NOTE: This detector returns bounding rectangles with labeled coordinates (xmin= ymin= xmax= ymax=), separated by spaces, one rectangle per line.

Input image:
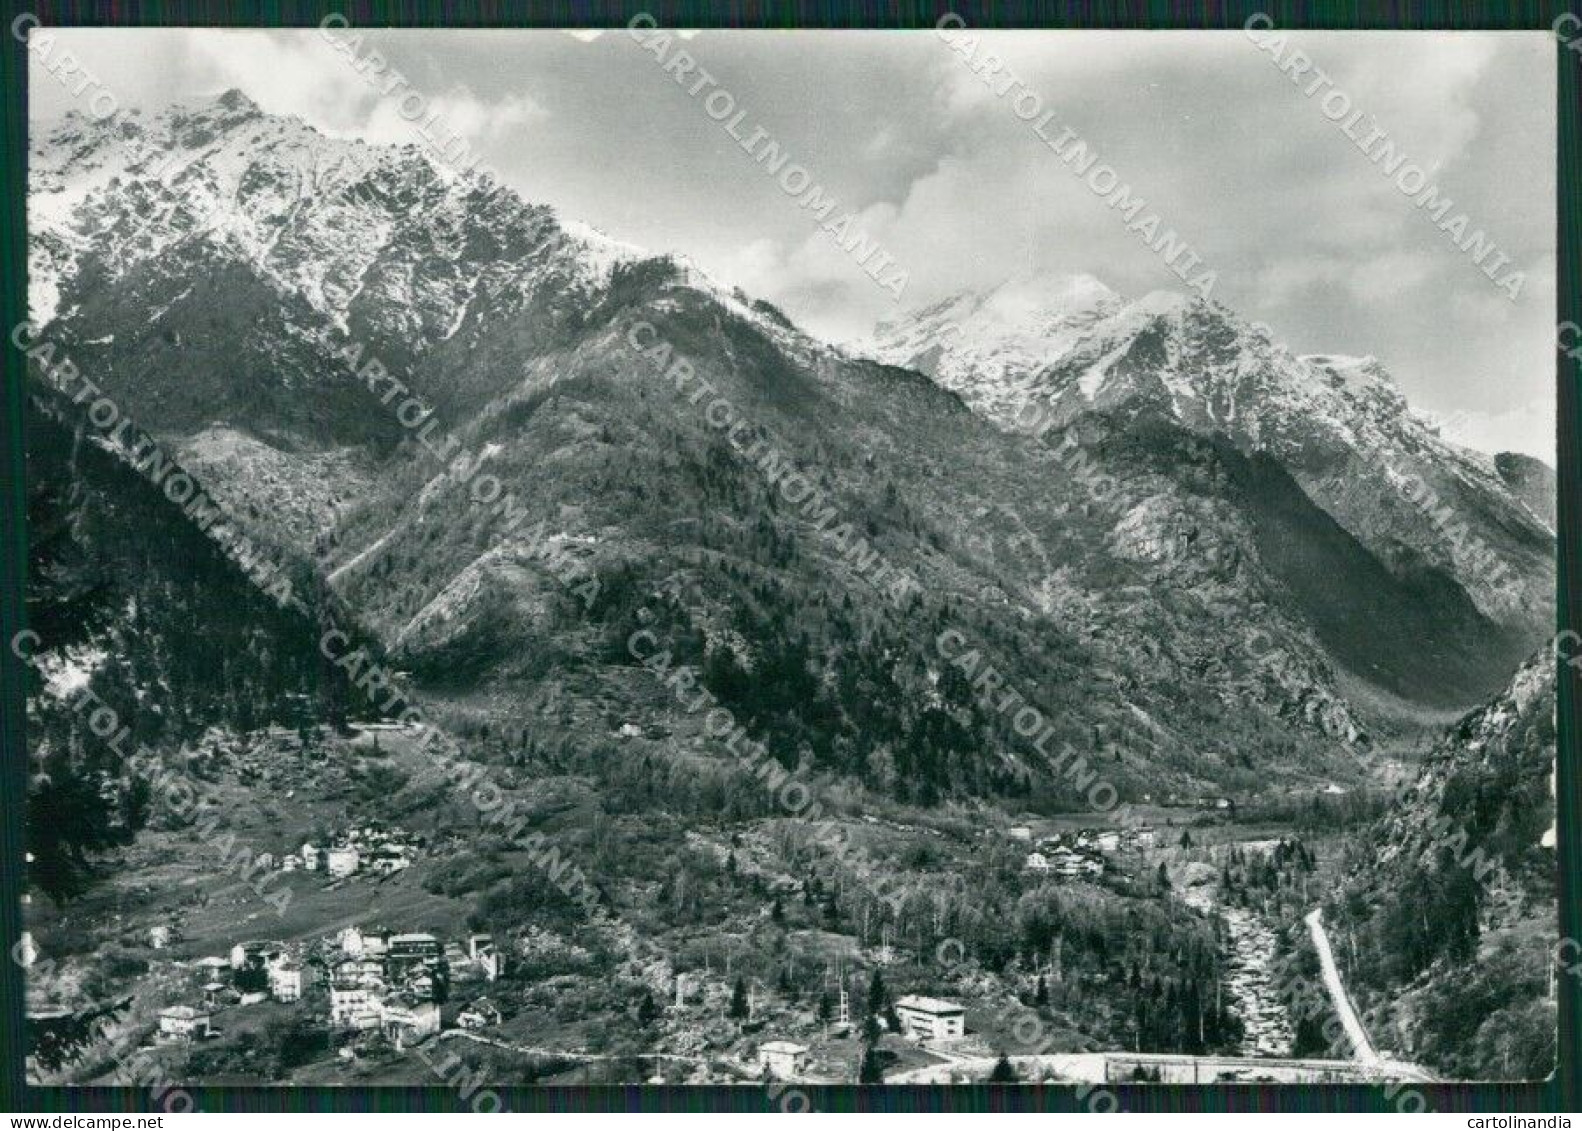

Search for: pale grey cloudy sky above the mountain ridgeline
xmin=30 ymin=30 xmax=1555 ymax=463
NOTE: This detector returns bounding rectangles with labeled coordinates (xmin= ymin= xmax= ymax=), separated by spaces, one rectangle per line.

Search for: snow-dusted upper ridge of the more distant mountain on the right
xmin=867 ymin=277 xmax=1549 ymax=629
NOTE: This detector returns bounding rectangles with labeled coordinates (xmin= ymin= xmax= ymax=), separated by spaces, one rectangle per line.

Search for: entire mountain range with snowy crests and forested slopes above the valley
xmin=30 ymin=93 xmax=1549 ymax=799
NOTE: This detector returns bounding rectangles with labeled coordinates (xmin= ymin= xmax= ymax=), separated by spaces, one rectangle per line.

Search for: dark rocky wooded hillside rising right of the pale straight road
xmin=1334 ymin=649 xmax=1565 ymax=1080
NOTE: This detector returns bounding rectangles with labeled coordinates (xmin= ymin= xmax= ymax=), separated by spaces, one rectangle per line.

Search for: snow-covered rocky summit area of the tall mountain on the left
xmin=28 ymin=90 xmax=645 ymax=332
